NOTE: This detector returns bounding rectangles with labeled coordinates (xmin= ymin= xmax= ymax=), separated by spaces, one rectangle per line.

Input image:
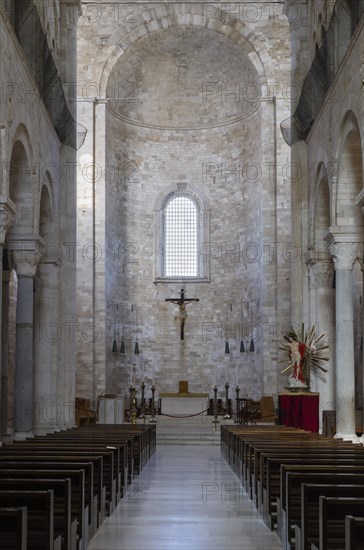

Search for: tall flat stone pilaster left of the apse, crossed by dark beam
xmin=57 ymin=0 xmax=81 ymax=428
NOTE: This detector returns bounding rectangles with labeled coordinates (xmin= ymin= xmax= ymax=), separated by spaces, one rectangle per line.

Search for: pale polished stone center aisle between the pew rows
xmin=88 ymin=445 xmax=282 ymax=550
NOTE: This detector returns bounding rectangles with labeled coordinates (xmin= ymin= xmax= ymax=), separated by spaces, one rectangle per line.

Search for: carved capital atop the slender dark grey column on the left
xmin=6 ymin=235 xmax=45 ymax=277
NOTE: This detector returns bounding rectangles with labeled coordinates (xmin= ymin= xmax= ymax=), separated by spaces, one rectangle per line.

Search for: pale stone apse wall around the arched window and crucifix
xmin=77 ymin=2 xmax=290 ymax=406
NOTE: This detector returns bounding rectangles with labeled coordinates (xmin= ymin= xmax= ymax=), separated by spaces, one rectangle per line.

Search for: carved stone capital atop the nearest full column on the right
xmin=324 ymin=227 xmax=363 ymax=270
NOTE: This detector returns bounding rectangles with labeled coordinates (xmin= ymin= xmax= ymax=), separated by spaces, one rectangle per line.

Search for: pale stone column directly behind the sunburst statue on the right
xmin=306 ymin=252 xmax=336 ymax=433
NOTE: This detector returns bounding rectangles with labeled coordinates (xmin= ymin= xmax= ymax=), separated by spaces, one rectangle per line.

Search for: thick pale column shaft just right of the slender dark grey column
xmin=34 ymin=261 xmax=62 ymax=435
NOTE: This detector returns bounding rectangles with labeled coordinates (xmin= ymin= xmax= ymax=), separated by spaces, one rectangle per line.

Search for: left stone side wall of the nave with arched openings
xmin=0 ymin=2 xmax=77 ymax=433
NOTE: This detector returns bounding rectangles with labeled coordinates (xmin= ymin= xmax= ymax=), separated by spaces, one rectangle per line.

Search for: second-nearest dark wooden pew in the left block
xmin=0 ymin=490 xmax=61 ymax=550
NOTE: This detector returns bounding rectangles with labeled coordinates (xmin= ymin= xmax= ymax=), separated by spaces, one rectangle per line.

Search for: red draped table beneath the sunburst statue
xmin=278 ymin=392 xmax=319 ymax=432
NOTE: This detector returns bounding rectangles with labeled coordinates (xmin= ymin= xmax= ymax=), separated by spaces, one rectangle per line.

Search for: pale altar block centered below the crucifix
xmin=159 ymin=392 xmax=209 ymax=415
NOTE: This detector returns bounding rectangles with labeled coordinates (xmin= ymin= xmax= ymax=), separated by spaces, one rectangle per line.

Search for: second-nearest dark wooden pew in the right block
xmin=318 ymin=496 xmax=364 ymax=550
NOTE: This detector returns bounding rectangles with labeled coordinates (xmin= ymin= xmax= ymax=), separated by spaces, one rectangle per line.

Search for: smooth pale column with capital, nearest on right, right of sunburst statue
xmin=326 ymin=233 xmax=361 ymax=442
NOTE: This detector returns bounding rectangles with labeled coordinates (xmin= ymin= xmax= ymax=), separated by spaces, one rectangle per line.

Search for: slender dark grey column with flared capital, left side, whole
xmin=8 ymin=238 xmax=41 ymax=439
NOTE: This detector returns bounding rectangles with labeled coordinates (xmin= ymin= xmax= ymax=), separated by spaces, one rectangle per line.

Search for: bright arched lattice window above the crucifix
xmin=156 ymin=190 xmax=209 ymax=282
